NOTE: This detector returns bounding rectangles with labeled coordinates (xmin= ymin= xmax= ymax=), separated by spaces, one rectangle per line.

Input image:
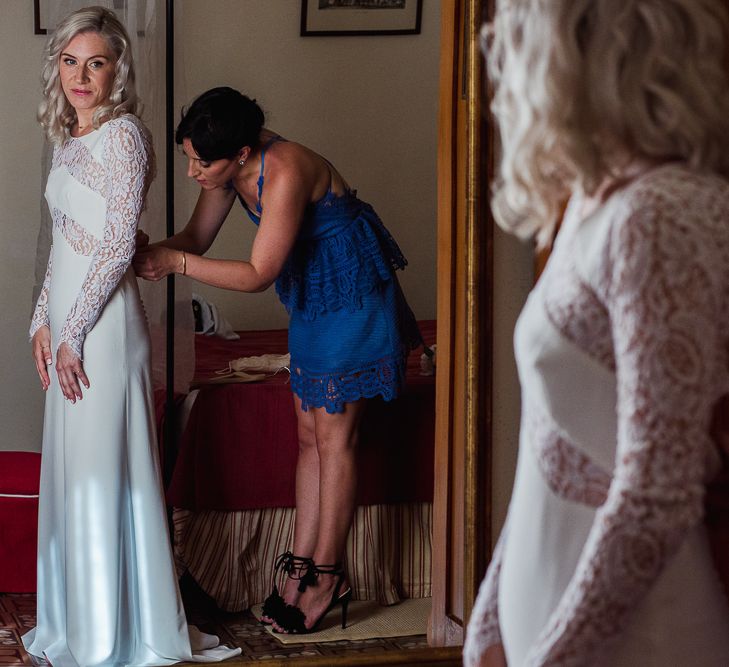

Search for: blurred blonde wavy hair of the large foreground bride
xmin=482 ymin=0 xmax=729 ymax=245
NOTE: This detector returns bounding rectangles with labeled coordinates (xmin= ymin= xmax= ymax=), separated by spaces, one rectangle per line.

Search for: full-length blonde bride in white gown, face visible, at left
xmin=23 ymin=7 xmax=240 ymax=667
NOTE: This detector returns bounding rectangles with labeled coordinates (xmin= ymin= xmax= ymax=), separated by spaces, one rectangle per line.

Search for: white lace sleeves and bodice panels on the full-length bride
xmin=30 ymin=116 xmax=151 ymax=357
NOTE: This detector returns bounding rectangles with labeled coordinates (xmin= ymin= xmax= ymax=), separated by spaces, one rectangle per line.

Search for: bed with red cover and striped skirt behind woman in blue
xmin=160 ymin=321 xmax=436 ymax=611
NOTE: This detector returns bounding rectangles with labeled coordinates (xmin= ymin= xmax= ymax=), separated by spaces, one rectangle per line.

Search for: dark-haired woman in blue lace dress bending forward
xmin=134 ymin=88 xmax=421 ymax=633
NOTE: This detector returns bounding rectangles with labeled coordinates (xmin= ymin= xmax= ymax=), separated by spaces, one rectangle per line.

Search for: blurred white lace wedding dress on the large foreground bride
xmin=464 ymin=164 xmax=729 ymax=667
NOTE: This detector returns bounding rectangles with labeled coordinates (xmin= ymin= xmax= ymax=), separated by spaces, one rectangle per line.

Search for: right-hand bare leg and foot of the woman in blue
xmin=276 ymin=399 xmax=365 ymax=630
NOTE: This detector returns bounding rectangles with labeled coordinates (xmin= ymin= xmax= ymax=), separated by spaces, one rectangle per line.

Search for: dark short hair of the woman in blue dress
xmin=175 ymin=86 xmax=264 ymax=162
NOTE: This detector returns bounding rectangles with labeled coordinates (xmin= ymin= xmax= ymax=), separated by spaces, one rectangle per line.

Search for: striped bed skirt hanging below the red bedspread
xmin=173 ymin=503 xmax=433 ymax=611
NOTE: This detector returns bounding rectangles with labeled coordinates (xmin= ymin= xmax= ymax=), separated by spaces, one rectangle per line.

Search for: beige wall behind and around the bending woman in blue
xmin=176 ymin=0 xmax=440 ymax=329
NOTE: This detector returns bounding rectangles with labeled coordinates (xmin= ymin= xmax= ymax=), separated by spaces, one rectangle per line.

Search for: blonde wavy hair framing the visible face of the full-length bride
xmin=38 ymin=7 xmax=141 ymax=144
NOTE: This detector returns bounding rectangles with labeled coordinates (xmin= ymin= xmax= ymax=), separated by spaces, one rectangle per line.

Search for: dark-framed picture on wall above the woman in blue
xmin=301 ymin=0 xmax=423 ymax=37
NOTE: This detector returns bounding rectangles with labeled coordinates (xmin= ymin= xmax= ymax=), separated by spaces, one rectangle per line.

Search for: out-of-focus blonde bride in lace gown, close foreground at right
xmin=464 ymin=0 xmax=729 ymax=666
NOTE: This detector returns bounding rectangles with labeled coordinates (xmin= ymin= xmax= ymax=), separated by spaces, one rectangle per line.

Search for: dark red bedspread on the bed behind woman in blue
xmin=168 ymin=320 xmax=435 ymax=510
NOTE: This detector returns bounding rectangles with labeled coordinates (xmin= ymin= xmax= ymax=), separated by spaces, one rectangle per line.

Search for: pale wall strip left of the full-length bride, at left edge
xmin=0 ymin=0 xmax=45 ymax=450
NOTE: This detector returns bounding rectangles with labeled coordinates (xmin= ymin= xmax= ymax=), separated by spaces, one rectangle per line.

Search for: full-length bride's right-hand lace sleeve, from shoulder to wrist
xmin=59 ymin=118 xmax=149 ymax=357
